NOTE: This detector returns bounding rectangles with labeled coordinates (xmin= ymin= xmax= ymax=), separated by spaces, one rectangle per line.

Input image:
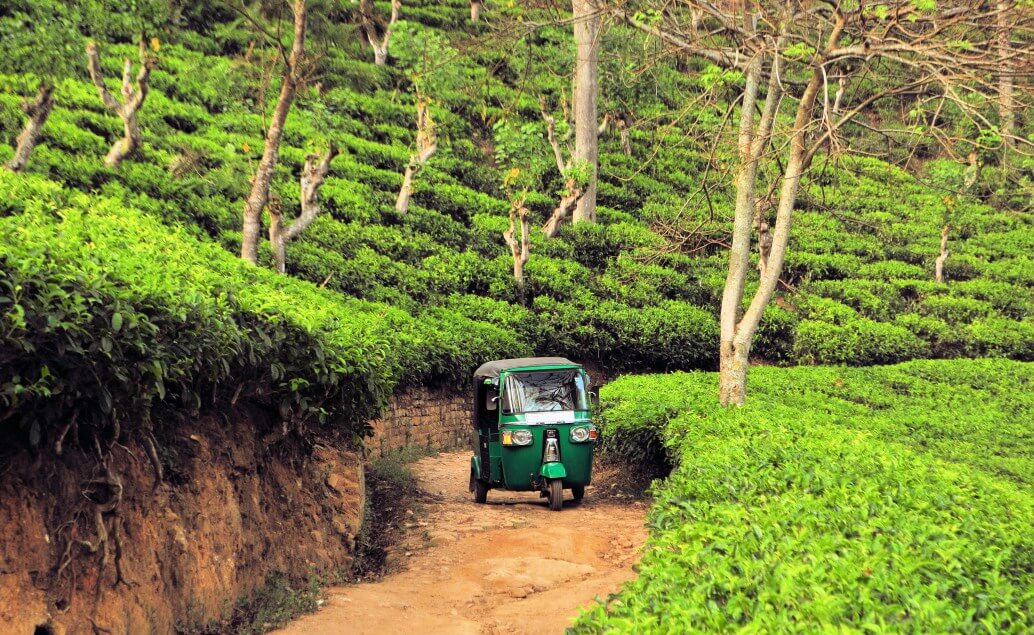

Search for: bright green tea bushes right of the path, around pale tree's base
xmin=575 ymin=360 xmax=1034 ymax=633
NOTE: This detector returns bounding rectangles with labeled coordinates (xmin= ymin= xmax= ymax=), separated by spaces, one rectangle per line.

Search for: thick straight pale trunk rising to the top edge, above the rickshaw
xmin=571 ymin=0 xmax=600 ymax=222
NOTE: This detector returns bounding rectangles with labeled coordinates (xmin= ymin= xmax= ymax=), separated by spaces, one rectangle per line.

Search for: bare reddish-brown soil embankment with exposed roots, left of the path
xmin=0 ymin=407 xmax=364 ymax=635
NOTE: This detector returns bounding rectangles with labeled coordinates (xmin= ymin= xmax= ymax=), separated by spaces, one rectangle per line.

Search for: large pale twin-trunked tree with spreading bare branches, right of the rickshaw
xmin=611 ymin=0 xmax=1031 ymax=404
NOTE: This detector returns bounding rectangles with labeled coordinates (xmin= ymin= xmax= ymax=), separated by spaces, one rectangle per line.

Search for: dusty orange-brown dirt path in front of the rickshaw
xmin=277 ymin=453 xmax=646 ymax=635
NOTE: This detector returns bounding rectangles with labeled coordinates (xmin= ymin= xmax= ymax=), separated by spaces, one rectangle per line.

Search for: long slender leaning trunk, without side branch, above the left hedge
xmin=241 ymin=0 xmax=306 ymax=265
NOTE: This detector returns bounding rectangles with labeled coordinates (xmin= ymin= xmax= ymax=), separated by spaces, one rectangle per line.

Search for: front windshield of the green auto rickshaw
xmin=503 ymin=369 xmax=588 ymax=415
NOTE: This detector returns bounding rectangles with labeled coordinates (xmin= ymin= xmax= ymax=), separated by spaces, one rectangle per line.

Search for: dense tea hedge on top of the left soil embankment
xmin=0 ymin=172 xmax=530 ymax=452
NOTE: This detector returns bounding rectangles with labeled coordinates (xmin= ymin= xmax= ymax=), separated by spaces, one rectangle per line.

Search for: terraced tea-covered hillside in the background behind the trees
xmin=0 ymin=0 xmax=1034 ymax=374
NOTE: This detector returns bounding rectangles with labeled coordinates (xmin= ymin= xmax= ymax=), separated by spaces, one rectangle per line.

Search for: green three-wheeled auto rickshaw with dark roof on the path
xmin=470 ymin=357 xmax=597 ymax=511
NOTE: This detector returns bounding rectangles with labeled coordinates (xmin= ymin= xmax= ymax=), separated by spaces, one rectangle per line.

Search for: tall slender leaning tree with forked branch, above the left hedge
xmin=235 ymin=0 xmax=307 ymax=265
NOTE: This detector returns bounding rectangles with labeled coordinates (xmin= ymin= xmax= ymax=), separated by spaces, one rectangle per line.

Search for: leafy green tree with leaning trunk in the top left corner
xmin=0 ymin=0 xmax=82 ymax=172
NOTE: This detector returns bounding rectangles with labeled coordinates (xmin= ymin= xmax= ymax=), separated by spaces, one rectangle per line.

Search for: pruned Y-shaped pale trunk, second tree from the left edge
xmin=86 ymin=38 xmax=154 ymax=168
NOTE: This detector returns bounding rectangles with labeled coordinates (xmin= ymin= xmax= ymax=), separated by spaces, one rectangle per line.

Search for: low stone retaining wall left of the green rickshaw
xmin=366 ymin=388 xmax=472 ymax=456
